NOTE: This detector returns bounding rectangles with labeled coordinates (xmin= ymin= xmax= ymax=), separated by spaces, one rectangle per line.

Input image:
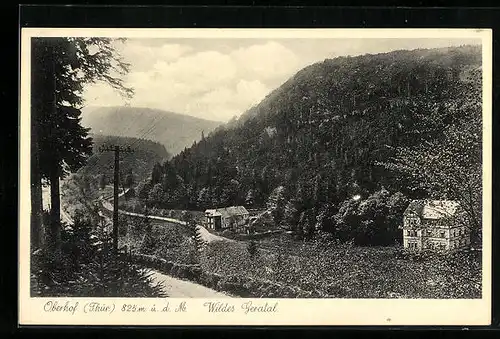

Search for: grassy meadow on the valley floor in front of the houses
xmin=118 ymin=215 xmax=481 ymax=299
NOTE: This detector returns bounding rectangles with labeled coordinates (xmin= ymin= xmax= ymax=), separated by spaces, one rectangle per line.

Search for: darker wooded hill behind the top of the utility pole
xmin=78 ymin=134 xmax=170 ymax=186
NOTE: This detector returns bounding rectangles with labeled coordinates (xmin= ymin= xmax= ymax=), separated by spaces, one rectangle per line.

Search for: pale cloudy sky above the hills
xmin=84 ymin=38 xmax=480 ymax=122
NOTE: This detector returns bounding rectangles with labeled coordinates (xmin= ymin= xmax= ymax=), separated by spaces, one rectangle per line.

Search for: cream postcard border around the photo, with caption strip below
xmin=18 ymin=28 xmax=492 ymax=326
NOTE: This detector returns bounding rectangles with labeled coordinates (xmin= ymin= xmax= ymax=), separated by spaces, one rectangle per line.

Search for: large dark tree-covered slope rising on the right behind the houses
xmin=138 ymin=46 xmax=482 ymax=244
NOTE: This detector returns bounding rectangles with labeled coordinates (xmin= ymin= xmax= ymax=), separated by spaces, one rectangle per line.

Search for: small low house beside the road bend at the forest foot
xmin=205 ymin=206 xmax=249 ymax=230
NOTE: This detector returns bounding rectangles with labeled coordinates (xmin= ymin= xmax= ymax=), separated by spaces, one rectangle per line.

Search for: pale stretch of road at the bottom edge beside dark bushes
xmin=151 ymin=270 xmax=231 ymax=298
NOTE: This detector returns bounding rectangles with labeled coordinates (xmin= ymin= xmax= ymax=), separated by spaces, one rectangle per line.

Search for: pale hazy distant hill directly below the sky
xmin=82 ymin=107 xmax=221 ymax=154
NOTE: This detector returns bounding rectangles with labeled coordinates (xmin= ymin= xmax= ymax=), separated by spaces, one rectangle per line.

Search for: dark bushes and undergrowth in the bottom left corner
xmin=31 ymin=218 xmax=164 ymax=297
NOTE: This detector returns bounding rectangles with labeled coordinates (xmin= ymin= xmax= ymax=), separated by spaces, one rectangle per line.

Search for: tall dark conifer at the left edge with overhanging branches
xmin=31 ymin=38 xmax=133 ymax=252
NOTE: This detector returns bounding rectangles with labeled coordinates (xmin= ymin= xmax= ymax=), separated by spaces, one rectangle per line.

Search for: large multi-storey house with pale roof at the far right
xmin=400 ymin=200 xmax=470 ymax=251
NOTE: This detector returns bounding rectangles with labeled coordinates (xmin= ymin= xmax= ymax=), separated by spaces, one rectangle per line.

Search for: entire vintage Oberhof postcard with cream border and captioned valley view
xmin=19 ymin=28 xmax=492 ymax=326
